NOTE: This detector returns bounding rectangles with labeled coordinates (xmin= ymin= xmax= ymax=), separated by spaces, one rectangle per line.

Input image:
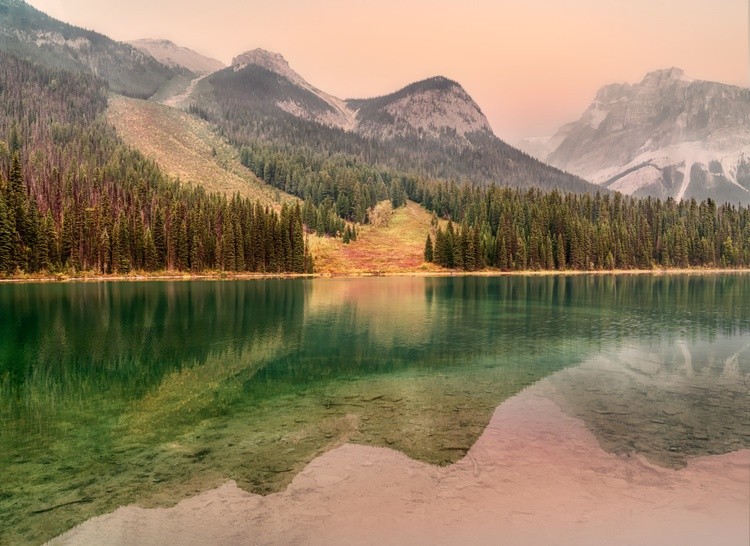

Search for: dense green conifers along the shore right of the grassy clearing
xmin=420 ymin=184 xmax=750 ymax=271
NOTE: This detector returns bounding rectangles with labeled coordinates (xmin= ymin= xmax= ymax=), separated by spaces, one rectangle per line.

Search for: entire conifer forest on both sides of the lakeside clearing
xmin=0 ymin=49 xmax=750 ymax=274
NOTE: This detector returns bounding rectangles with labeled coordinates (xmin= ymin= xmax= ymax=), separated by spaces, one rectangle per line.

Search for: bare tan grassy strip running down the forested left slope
xmin=107 ymin=96 xmax=296 ymax=204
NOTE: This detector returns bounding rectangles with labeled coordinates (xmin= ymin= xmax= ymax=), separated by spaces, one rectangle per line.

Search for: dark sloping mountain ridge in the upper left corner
xmin=0 ymin=0 xmax=185 ymax=98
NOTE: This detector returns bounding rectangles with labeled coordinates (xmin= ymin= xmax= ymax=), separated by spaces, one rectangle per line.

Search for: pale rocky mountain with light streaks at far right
xmin=522 ymin=68 xmax=750 ymax=203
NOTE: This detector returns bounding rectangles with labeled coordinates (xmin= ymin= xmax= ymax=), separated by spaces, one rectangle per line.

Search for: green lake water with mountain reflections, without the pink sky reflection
xmin=0 ymin=274 xmax=750 ymax=544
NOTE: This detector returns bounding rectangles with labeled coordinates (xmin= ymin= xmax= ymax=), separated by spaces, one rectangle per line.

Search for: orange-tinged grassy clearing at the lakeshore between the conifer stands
xmin=310 ymin=201 xmax=442 ymax=275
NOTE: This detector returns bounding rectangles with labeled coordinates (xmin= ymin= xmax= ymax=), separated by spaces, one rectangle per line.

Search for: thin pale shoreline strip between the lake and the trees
xmin=0 ymin=267 xmax=750 ymax=284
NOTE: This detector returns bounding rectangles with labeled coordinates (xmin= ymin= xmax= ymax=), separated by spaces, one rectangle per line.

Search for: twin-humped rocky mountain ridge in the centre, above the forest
xmin=189 ymin=49 xmax=598 ymax=192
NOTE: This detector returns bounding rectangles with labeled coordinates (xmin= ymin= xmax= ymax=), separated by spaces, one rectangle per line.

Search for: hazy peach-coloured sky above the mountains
xmin=30 ymin=0 xmax=750 ymax=140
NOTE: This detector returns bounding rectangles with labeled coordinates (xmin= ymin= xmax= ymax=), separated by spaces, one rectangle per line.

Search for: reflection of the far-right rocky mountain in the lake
xmin=550 ymin=335 xmax=750 ymax=468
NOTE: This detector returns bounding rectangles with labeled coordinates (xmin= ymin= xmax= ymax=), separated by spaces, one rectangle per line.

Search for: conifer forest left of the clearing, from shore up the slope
xmin=0 ymin=54 xmax=312 ymax=274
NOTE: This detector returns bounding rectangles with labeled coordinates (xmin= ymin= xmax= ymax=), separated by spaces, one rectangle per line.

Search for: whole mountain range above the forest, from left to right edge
xmin=0 ymin=0 xmax=750 ymax=202
